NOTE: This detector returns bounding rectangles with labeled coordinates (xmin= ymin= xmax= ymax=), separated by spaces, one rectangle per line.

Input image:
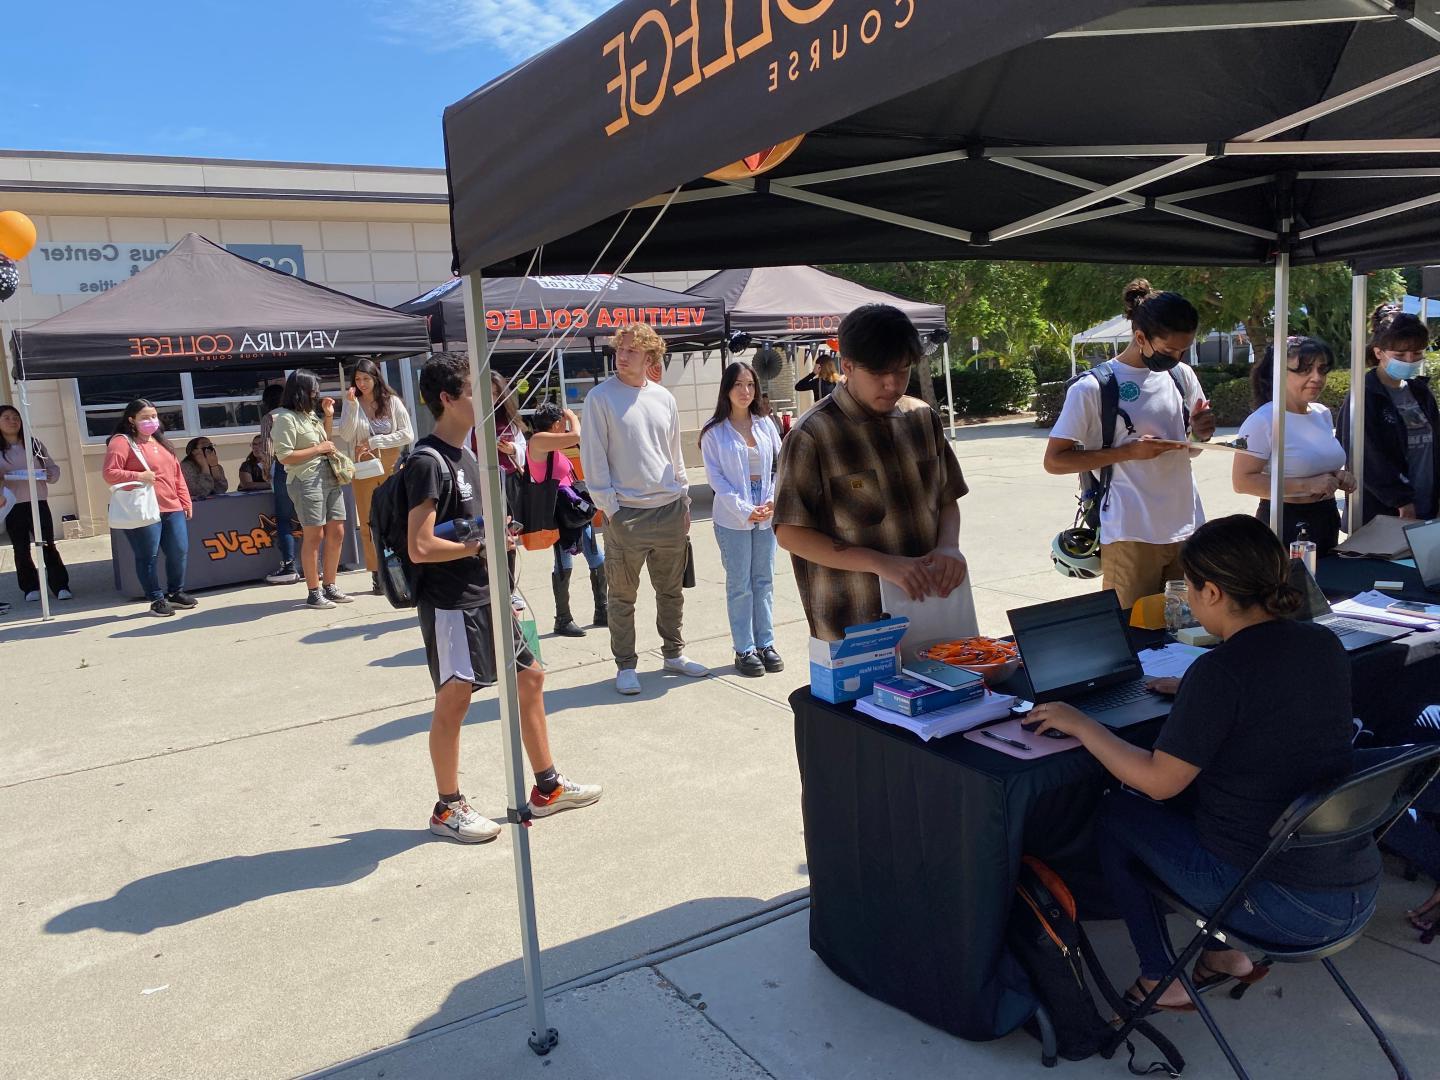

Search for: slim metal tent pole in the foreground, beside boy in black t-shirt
xmin=465 ymin=274 xmax=557 ymax=1054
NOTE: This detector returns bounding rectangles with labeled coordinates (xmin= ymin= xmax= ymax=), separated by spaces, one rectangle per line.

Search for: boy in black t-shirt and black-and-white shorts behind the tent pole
xmin=403 ymin=353 xmax=600 ymax=844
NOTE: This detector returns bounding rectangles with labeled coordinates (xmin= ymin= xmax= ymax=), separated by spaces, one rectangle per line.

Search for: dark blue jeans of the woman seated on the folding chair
xmin=1096 ymin=792 xmax=1378 ymax=979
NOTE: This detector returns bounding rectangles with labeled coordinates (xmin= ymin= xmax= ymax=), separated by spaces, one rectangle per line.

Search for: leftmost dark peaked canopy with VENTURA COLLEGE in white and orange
xmin=12 ymin=233 xmax=431 ymax=380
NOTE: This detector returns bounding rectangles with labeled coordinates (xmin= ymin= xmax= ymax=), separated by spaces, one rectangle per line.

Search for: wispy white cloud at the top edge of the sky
xmin=377 ymin=0 xmax=615 ymax=60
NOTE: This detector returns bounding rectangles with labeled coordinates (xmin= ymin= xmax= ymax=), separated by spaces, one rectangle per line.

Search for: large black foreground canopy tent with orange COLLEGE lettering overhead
xmin=445 ymin=0 xmax=1440 ymax=1041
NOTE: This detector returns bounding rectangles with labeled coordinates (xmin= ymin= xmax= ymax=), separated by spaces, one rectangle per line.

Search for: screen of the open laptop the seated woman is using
xmin=1007 ymin=589 xmax=1140 ymax=701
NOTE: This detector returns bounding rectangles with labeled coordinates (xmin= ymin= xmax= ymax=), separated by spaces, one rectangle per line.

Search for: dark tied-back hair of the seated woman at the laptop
xmin=1179 ymin=514 xmax=1305 ymax=618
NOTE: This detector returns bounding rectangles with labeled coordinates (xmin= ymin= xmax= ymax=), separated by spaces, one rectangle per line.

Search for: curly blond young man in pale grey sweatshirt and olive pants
xmin=580 ymin=323 xmax=708 ymax=694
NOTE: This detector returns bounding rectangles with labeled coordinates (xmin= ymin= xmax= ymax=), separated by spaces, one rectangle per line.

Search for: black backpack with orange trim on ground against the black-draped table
xmin=1005 ymin=855 xmax=1185 ymax=1077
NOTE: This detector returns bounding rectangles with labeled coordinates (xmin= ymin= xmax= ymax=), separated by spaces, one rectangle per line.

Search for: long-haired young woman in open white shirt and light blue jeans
xmin=700 ymin=361 xmax=785 ymax=678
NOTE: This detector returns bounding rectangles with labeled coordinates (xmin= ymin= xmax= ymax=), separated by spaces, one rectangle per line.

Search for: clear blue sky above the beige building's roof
xmin=11 ymin=0 xmax=611 ymax=167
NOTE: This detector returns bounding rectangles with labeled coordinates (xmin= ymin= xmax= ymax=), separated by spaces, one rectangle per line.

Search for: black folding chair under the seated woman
xmin=1102 ymin=743 xmax=1440 ymax=1080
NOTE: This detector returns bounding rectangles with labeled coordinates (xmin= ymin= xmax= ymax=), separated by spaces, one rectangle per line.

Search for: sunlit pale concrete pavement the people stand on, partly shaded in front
xmin=8 ymin=422 xmax=1440 ymax=1080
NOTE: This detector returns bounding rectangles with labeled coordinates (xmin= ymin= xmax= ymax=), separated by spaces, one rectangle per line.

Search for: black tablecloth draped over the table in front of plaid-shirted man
xmin=791 ymin=616 xmax=1440 ymax=1040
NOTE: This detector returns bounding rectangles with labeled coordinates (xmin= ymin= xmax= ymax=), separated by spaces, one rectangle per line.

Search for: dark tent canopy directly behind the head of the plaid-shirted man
xmin=682 ymin=266 xmax=945 ymax=338
